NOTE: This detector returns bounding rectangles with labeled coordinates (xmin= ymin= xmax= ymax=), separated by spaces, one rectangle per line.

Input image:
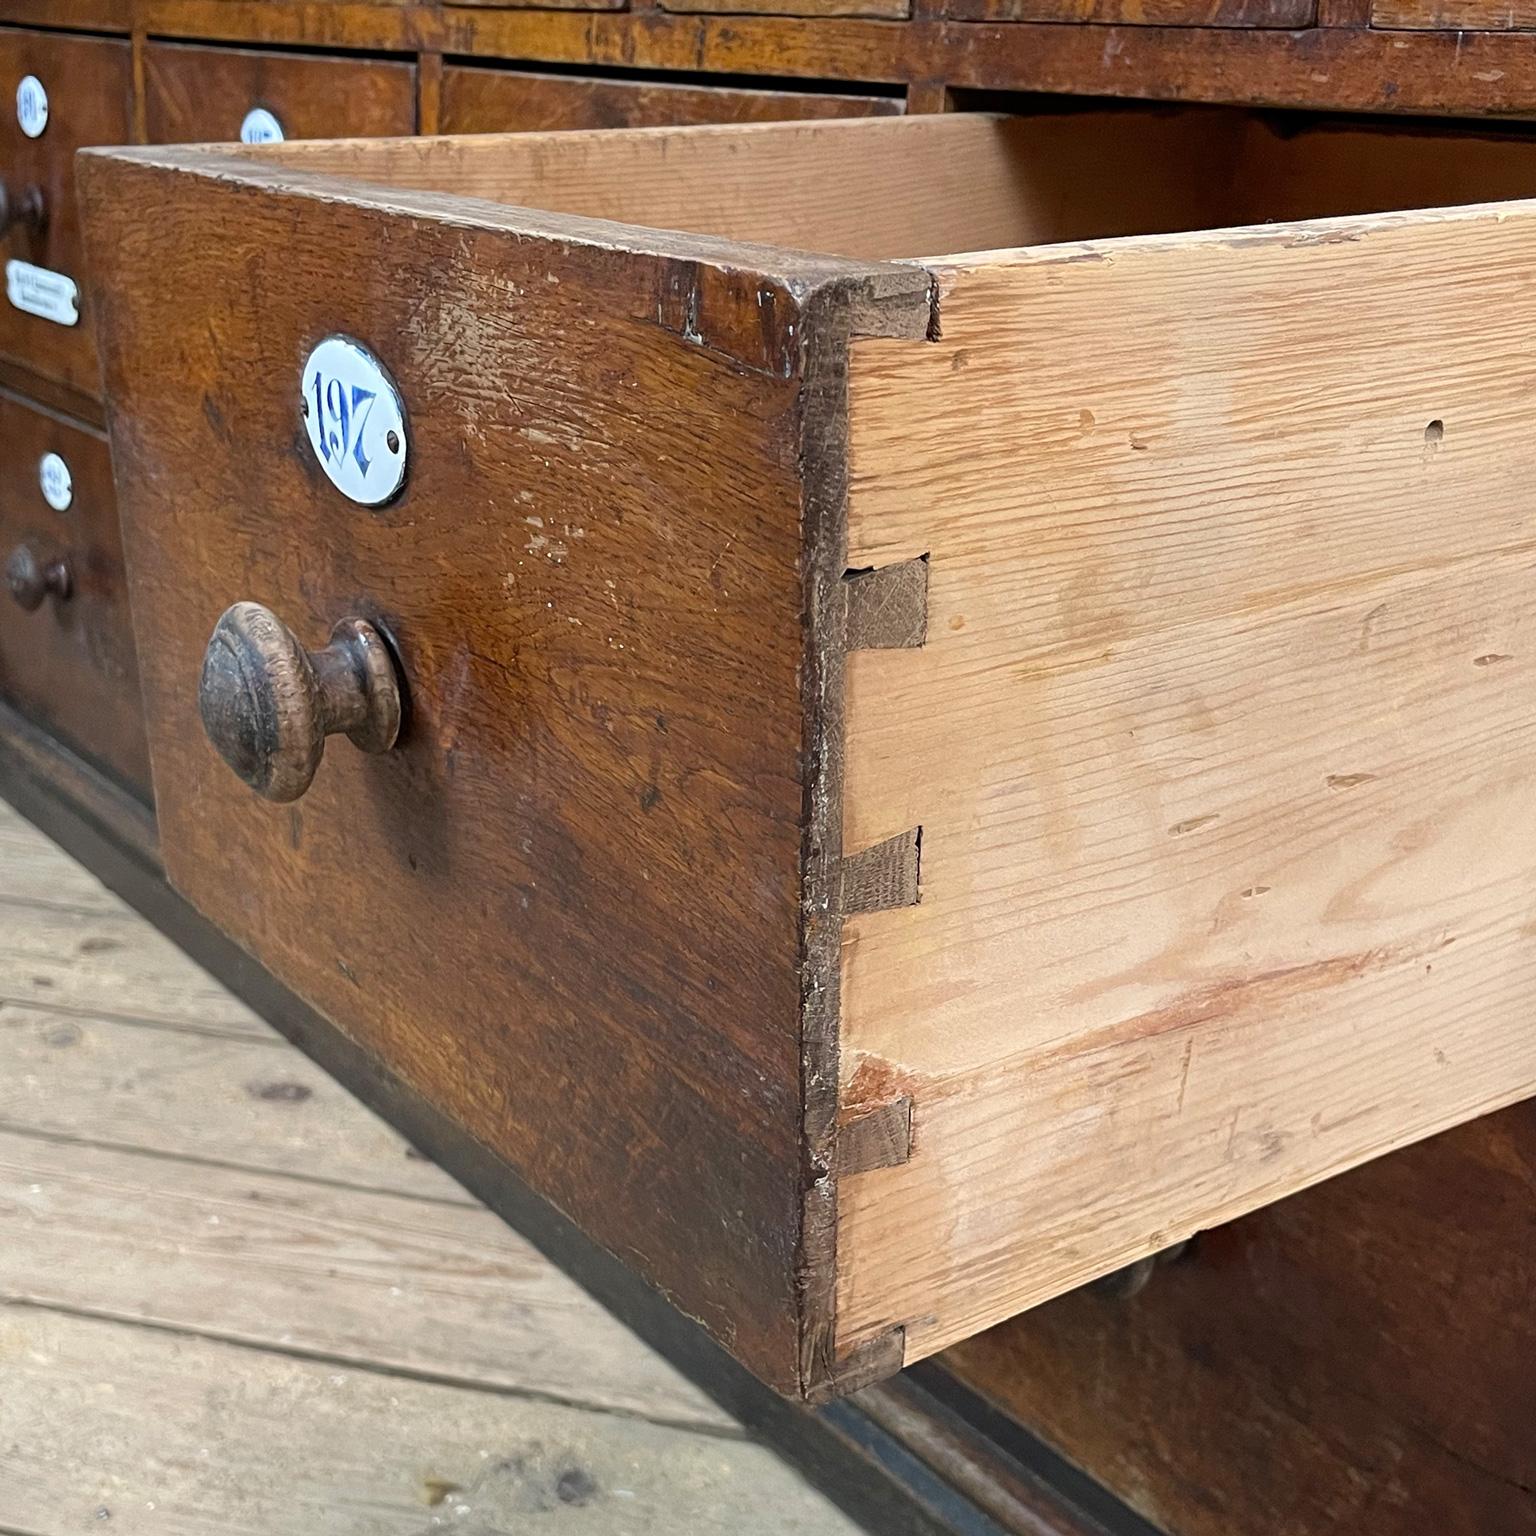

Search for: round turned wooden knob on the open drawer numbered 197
xmin=198 ymin=602 xmax=399 ymax=802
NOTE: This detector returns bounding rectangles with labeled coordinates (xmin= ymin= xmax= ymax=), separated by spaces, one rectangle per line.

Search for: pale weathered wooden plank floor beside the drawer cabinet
xmin=0 ymin=802 xmax=854 ymax=1536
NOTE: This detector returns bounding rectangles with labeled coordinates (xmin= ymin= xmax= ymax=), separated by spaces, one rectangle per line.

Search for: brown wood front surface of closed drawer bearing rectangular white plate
xmin=0 ymin=29 xmax=134 ymax=395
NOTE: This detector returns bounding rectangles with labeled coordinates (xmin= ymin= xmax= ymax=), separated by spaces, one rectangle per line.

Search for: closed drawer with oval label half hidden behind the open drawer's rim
xmin=144 ymin=43 xmax=416 ymax=144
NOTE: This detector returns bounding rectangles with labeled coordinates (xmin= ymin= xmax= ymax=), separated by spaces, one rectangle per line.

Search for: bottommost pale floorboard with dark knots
xmin=0 ymin=1307 xmax=854 ymax=1536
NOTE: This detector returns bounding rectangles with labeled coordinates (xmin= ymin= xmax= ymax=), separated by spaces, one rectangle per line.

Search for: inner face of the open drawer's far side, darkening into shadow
xmin=241 ymin=111 xmax=1247 ymax=261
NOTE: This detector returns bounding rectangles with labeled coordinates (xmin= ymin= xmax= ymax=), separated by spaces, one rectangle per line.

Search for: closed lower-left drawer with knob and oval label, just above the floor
xmin=0 ymin=393 xmax=149 ymax=799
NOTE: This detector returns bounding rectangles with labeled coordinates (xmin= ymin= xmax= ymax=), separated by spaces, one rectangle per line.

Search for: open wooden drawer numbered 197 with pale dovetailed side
xmin=83 ymin=111 xmax=1536 ymax=1396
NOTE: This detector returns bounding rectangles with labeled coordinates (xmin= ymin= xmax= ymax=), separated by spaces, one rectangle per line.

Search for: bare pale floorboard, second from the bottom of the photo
xmin=0 ymin=1130 xmax=739 ymax=1435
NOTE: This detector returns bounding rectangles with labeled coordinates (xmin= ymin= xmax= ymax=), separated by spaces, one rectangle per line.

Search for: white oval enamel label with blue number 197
xmin=300 ymin=336 xmax=409 ymax=507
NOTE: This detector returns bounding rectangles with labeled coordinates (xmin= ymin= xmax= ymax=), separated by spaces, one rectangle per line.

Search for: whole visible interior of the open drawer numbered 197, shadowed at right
xmin=255 ymin=108 xmax=1536 ymax=261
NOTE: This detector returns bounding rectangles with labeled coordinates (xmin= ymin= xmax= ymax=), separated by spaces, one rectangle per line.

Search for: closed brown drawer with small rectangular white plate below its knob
xmin=0 ymin=28 xmax=134 ymax=396
